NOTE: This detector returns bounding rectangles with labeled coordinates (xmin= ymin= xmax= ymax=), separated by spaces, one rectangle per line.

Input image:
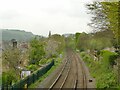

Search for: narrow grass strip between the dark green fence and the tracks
xmin=28 ymin=53 xmax=64 ymax=88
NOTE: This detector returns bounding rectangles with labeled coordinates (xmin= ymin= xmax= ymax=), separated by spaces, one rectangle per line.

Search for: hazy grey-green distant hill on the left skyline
xmin=0 ymin=29 xmax=35 ymax=41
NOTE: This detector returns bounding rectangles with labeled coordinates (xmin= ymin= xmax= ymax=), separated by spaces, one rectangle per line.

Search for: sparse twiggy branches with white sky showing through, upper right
xmin=86 ymin=2 xmax=109 ymax=31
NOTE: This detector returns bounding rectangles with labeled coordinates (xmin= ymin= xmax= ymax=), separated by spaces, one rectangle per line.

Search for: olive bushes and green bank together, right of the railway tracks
xmin=67 ymin=30 xmax=118 ymax=88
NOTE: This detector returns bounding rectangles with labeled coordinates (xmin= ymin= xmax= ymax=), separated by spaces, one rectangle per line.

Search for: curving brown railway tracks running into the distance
xmin=49 ymin=50 xmax=87 ymax=90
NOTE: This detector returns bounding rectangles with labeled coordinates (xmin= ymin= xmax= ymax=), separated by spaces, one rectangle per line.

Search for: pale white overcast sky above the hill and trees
xmin=0 ymin=0 xmax=98 ymax=36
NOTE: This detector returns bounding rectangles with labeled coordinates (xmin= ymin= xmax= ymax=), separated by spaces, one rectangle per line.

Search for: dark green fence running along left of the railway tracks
xmin=3 ymin=60 xmax=54 ymax=90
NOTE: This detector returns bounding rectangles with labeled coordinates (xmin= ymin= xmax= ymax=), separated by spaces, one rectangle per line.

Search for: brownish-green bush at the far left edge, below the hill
xmin=2 ymin=48 xmax=20 ymax=72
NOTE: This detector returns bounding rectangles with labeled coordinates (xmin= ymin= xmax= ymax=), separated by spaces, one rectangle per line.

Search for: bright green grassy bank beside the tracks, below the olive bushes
xmin=80 ymin=51 xmax=118 ymax=88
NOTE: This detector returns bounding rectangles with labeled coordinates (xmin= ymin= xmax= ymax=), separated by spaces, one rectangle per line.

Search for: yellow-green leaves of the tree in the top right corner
xmin=101 ymin=2 xmax=120 ymax=37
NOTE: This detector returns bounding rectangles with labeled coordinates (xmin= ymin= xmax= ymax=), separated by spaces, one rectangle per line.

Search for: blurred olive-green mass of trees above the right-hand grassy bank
xmin=75 ymin=31 xmax=113 ymax=51
